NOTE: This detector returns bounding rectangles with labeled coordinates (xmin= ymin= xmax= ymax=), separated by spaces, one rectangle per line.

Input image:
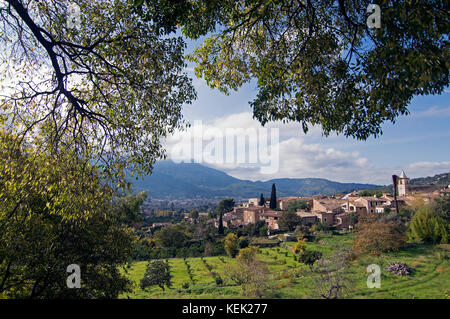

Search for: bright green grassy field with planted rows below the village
xmin=121 ymin=234 xmax=450 ymax=299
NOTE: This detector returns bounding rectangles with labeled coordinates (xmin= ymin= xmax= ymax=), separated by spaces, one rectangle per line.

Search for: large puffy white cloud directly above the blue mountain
xmin=166 ymin=112 xmax=378 ymax=182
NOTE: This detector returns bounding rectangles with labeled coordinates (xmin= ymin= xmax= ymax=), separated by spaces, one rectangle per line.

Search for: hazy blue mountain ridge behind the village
xmin=132 ymin=161 xmax=377 ymax=199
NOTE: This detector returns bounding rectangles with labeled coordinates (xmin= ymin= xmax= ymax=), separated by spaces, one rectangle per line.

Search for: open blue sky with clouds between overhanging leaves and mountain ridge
xmin=164 ymin=43 xmax=450 ymax=184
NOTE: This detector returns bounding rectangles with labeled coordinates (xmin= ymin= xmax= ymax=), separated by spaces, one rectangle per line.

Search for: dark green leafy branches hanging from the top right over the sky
xmin=177 ymin=0 xmax=450 ymax=139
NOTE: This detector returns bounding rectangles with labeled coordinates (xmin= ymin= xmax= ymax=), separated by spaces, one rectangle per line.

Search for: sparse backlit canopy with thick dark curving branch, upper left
xmin=0 ymin=0 xmax=195 ymax=177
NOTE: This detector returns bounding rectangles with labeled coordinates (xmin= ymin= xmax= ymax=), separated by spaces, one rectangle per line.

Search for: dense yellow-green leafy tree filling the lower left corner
xmin=0 ymin=131 xmax=135 ymax=298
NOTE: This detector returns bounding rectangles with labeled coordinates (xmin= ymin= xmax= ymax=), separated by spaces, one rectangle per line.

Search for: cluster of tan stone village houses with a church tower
xmin=210 ymin=171 xmax=450 ymax=234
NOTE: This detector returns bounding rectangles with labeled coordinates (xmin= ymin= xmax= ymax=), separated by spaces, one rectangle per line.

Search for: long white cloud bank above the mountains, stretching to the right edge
xmin=166 ymin=112 xmax=450 ymax=185
